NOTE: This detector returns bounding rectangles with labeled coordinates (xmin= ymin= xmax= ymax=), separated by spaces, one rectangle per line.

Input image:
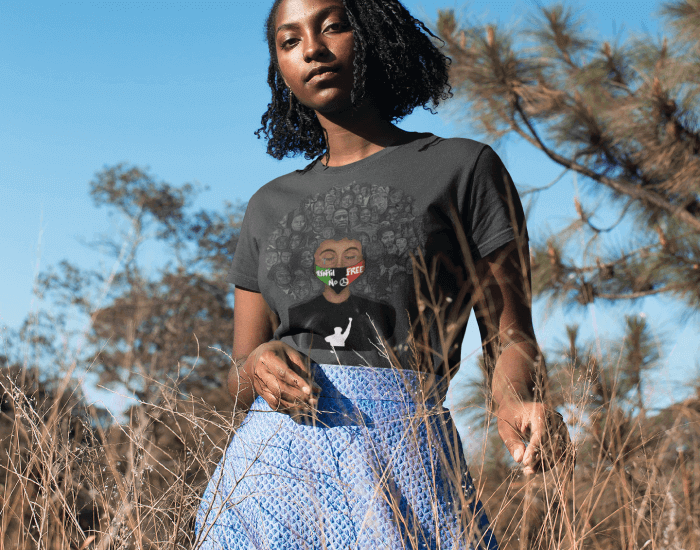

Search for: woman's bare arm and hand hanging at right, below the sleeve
xmin=474 ymin=242 xmax=570 ymax=474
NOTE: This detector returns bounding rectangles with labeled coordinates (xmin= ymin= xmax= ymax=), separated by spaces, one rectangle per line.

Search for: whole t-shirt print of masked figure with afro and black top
xmin=264 ymin=183 xmax=424 ymax=351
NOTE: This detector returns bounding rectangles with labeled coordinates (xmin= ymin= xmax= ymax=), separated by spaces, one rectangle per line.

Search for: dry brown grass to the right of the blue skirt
xmin=456 ymin=366 xmax=700 ymax=550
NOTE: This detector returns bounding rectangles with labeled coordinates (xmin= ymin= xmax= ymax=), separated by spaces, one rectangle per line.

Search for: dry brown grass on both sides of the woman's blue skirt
xmin=0 ymin=356 xmax=700 ymax=550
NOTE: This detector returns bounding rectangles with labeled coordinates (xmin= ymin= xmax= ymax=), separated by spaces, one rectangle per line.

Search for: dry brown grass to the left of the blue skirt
xmin=0 ymin=369 xmax=235 ymax=550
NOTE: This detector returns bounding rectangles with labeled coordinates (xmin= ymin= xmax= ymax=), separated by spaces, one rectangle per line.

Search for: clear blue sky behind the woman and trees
xmin=0 ymin=0 xmax=698 ymax=414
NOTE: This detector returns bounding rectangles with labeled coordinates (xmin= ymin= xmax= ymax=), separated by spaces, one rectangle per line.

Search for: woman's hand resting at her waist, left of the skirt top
xmin=245 ymin=340 xmax=321 ymax=414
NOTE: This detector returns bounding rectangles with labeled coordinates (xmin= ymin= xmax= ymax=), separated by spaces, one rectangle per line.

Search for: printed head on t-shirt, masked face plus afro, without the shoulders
xmin=263 ymin=182 xmax=423 ymax=310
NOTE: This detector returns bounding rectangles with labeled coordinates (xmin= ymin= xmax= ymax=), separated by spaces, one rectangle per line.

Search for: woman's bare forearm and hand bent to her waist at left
xmin=228 ymin=287 xmax=318 ymax=413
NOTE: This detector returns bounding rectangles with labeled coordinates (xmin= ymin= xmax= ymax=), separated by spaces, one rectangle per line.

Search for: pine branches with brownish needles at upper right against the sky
xmin=437 ymin=0 xmax=700 ymax=310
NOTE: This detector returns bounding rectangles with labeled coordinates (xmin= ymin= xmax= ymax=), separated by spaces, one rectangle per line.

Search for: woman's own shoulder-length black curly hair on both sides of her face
xmin=255 ymin=0 xmax=452 ymax=160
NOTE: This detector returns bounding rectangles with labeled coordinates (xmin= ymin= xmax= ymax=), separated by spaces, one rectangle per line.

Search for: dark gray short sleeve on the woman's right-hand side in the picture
xmin=462 ymin=145 xmax=527 ymax=259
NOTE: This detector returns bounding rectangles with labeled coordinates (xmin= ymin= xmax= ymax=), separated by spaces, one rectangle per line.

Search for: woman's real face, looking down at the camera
xmin=275 ymin=0 xmax=354 ymax=114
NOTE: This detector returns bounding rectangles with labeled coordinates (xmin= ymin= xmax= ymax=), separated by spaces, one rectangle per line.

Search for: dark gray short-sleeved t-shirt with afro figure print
xmin=229 ymin=134 xmax=524 ymax=375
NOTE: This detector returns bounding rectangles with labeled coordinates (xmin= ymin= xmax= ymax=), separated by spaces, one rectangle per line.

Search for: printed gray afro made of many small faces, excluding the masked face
xmin=264 ymin=184 xmax=424 ymax=302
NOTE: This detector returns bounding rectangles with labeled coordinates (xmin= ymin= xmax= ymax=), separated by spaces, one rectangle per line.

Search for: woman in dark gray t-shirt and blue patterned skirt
xmin=197 ymin=0 xmax=568 ymax=549
